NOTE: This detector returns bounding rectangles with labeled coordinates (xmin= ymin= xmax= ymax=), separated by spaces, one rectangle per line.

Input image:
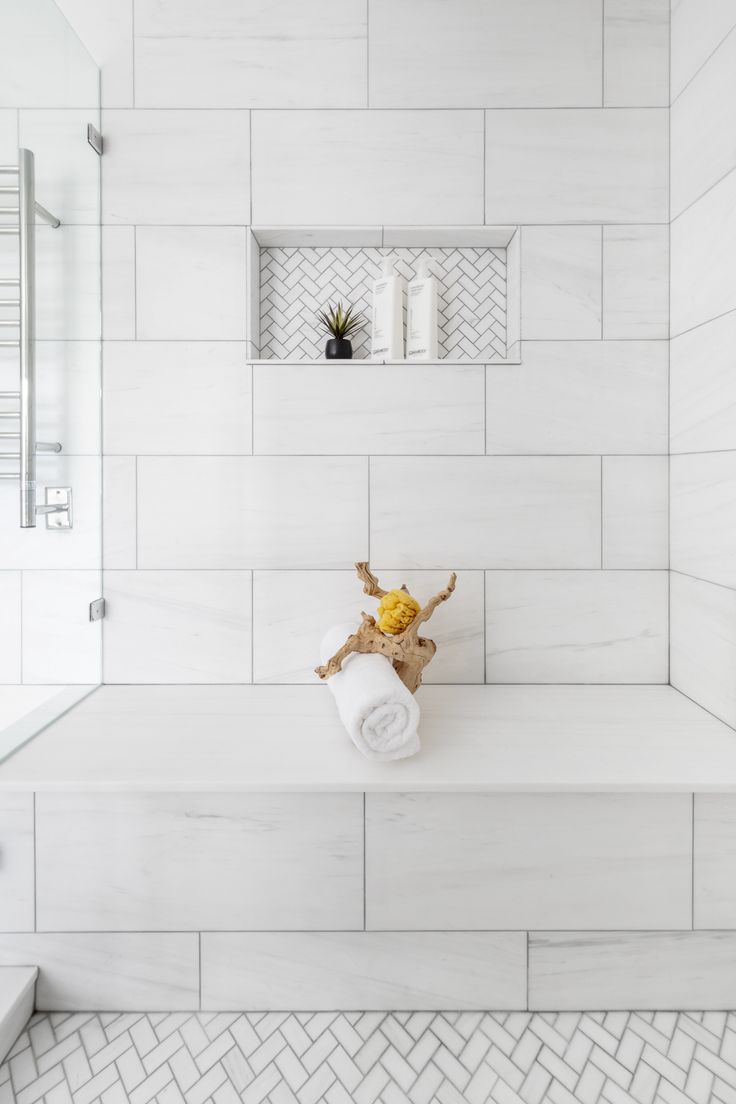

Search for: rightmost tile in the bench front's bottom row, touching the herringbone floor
xmin=529 ymin=924 xmax=736 ymax=1011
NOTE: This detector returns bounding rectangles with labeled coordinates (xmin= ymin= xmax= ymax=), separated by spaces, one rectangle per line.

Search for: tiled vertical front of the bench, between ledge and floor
xmin=10 ymin=790 xmax=736 ymax=1011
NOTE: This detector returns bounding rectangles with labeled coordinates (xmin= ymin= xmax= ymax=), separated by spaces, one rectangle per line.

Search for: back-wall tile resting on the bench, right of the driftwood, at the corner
xmin=486 ymin=571 xmax=669 ymax=682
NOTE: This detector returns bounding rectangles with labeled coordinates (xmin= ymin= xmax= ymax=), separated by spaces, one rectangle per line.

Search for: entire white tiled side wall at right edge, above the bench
xmin=671 ymin=0 xmax=736 ymax=725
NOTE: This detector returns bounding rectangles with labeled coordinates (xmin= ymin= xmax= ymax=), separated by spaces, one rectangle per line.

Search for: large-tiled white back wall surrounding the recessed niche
xmin=56 ymin=0 xmax=669 ymax=682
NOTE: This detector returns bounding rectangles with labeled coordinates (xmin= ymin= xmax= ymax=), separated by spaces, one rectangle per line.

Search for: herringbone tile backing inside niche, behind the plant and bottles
xmin=259 ymin=246 xmax=506 ymax=360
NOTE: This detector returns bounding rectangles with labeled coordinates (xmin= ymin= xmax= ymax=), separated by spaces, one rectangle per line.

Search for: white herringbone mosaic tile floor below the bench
xmin=0 ymin=1012 xmax=736 ymax=1104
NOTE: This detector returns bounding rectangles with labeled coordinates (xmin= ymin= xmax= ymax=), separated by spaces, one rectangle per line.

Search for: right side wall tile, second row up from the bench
xmin=670 ymin=453 xmax=736 ymax=587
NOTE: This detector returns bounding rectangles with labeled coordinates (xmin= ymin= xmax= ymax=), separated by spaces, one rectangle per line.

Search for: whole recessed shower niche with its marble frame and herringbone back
xmin=248 ymin=226 xmax=520 ymax=363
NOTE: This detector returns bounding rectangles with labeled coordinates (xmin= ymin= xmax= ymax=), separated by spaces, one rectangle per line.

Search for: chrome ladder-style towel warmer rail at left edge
xmin=0 ymin=149 xmax=72 ymax=529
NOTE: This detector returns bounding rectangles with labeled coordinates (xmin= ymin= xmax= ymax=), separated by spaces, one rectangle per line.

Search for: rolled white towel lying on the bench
xmin=320 ymin=624 xmax=422 ymax=762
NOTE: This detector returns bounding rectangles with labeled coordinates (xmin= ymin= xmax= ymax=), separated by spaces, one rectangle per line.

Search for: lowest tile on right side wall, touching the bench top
xmin=670 ymin=572 xmax=736 ymax=728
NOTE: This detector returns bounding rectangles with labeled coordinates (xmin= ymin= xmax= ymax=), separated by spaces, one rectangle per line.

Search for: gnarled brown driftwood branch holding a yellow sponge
xmin=316 ymin=562 xmax=457 ymax=693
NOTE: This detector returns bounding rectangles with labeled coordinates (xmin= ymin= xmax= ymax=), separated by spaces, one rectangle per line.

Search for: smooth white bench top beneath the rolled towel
xmin=0 ymin=684 xmax=736 ymax=793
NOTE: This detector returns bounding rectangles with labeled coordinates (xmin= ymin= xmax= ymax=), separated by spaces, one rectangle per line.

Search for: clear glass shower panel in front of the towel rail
xmin=0 ymin=0 xmax=102 ymax=758
